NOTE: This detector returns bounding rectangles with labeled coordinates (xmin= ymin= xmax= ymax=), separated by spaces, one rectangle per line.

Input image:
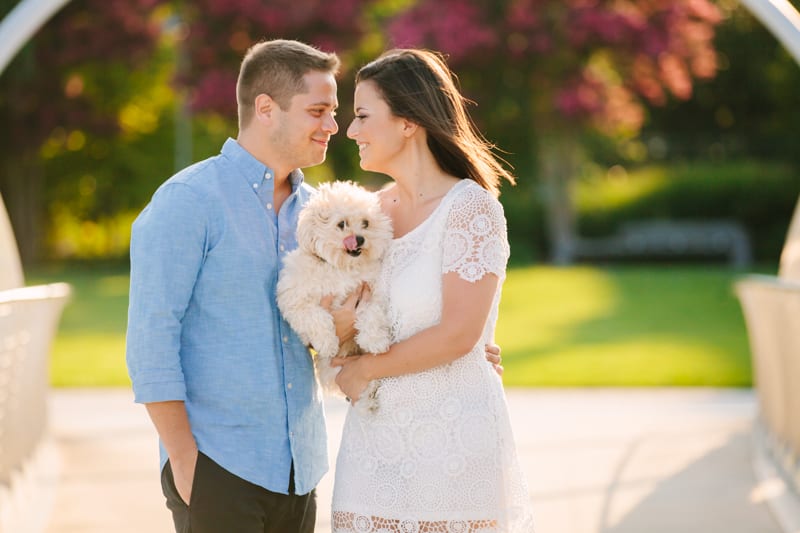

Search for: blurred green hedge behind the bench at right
xmin=576 ymin=160 xmax=800 ymax=261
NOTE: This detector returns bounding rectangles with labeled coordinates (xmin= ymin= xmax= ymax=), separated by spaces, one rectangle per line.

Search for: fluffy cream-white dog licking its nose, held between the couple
xmin=278 ymin=181 xmax=393 ymax=411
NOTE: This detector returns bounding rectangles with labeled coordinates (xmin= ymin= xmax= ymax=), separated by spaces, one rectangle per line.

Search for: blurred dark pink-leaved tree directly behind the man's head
xmin=178 ymin=0 xmax=400 ymax=187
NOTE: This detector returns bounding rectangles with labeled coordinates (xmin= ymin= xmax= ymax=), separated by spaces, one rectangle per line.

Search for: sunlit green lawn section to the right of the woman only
xmin=497 ymin=266 xmax=752 ymax=386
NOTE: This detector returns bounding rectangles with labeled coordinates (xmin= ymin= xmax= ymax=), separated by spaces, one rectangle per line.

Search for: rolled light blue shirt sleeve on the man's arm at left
xmin=126 ymin=183 xmax=208 ymax=403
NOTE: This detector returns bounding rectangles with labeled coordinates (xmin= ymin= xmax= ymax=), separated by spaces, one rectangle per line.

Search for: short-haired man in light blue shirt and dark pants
xmin=127 ymin=40 xmax=344 ymax=533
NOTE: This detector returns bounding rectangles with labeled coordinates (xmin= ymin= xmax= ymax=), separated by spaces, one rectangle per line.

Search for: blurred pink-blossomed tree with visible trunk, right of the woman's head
xmin=387 ymin=0 xmax=722 ymax=263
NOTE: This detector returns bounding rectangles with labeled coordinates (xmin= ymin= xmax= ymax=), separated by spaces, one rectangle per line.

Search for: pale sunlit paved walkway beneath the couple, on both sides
xmin=28 ymin=389 xmax=800 ymax=533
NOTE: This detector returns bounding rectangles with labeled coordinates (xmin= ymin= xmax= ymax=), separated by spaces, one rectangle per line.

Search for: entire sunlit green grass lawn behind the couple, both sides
xmin=27 ymin=266 xmax=752 ymax=387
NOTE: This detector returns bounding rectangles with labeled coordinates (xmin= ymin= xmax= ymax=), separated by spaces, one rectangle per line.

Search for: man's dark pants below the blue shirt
xmin=161 ymin=453 xmax=317 ymax=533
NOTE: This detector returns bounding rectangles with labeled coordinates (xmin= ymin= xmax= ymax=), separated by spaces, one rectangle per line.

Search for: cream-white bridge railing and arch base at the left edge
xmin=0 ymin=193 xmax=70 ymax=533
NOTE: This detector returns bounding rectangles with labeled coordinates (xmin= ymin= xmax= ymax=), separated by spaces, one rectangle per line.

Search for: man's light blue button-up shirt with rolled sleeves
xmin=127 ymin=139 xmax=328 ymax=494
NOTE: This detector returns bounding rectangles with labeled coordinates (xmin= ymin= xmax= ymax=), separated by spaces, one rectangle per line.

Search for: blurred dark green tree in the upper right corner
xmin=642 ymin=0 xmax=800 ymax=165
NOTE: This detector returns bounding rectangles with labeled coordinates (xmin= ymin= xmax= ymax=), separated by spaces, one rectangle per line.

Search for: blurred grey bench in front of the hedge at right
xmin=575 ymin=220 xmax=752 ymax=268
